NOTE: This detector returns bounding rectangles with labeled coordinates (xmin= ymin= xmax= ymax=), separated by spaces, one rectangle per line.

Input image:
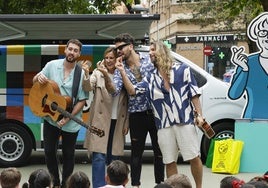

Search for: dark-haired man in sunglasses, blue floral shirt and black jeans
xmin=106 ymin=33 xmax=164 ymax=187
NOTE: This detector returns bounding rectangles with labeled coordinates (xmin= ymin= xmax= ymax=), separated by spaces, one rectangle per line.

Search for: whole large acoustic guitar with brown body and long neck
xmin=29 ymin=80 xmax=104 ymax=137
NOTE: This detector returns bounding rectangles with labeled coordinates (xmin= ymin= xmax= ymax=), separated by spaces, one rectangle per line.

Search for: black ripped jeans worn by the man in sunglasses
xmin=129 ymin=111 xmax=164 ymax=186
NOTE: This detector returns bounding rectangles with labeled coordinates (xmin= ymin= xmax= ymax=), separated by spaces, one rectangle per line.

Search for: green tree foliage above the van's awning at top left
xmin=0 ymin=0 xmax=140 ymax=14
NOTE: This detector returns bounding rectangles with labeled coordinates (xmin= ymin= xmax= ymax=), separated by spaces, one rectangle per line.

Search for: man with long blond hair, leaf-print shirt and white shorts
xmin=115 ymin=42 xmax=204 ymax=188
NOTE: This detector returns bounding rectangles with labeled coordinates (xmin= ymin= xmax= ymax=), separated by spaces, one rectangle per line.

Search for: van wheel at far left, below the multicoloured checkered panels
xmin=0 ymin=122 xmax=33 ymax=167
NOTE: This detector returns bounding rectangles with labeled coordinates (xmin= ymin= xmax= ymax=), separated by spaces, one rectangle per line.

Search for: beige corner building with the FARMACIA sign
xmin=149 ymin=0 xmax=248 ymax=79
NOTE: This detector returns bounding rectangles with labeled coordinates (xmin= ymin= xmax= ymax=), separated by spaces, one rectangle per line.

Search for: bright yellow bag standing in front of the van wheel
xmin=211 ymin=139 xmax=244 ymax=174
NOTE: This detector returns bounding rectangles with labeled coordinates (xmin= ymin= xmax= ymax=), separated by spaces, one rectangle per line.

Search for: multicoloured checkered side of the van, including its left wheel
xmin=0 ymin=45 xmax=108 ymax=167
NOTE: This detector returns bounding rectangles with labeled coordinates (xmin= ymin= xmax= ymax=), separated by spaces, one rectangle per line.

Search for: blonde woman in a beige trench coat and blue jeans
xmin=82 ymin=47 xmax=128 ymax=188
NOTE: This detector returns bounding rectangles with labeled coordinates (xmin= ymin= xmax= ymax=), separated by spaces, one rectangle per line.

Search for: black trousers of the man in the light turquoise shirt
xmin=43 ymin=121 xmax=78 ymax=187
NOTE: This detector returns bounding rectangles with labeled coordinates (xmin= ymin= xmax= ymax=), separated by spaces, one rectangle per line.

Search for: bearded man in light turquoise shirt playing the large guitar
xmin=33 ymin=39 xmax=88 ymax=187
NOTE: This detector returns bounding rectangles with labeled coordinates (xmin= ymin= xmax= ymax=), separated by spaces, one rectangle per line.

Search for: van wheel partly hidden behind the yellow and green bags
xmin=201 ymin=121 xmax=234 ymax=163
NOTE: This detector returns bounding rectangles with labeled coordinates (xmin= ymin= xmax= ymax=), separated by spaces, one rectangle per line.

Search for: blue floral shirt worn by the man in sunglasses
xmin=113 ymin=53 xmax=154 ymax=113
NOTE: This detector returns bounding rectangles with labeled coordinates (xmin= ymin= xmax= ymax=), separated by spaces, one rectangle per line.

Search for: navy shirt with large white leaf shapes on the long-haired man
xmin=134 ymin=62 xmax=200 ymax=129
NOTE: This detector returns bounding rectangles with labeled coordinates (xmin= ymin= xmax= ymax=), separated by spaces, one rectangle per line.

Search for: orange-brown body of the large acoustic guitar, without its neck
xmin=29 ymin=80 xmax=72 ymax=121
